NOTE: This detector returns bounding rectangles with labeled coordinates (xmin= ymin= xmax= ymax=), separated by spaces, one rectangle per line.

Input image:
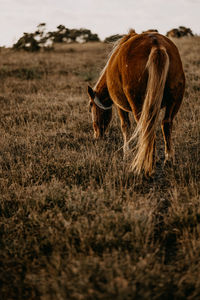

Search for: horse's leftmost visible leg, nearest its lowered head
xmin=117 ymin=107 xmax=131 ymax=157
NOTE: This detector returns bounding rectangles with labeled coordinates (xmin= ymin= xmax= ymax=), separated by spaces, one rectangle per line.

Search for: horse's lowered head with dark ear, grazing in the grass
xmin=88 ymin=86 xmax=112 ymax=139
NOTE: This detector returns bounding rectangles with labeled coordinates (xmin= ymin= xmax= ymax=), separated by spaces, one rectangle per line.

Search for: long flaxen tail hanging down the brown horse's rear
xmin=130 ymin=47 xmax=169 ymax=175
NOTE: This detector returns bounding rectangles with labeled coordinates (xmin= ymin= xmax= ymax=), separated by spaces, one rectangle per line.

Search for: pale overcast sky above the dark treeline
xmin=0 ymin=0 xmax=200 ymax=46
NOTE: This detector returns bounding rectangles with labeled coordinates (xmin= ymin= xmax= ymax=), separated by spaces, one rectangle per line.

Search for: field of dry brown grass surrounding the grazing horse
xmin=0 ymin=37 xmax=200 ymax=300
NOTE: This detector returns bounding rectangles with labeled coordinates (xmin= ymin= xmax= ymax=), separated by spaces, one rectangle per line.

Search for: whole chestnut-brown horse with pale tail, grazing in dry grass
xmin=88 ymin=30 xmax=185 ymax=175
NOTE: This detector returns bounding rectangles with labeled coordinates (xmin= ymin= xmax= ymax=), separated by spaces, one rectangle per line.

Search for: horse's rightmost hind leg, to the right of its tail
xmin=161 ymin=101 xmax=181 ymax=163
